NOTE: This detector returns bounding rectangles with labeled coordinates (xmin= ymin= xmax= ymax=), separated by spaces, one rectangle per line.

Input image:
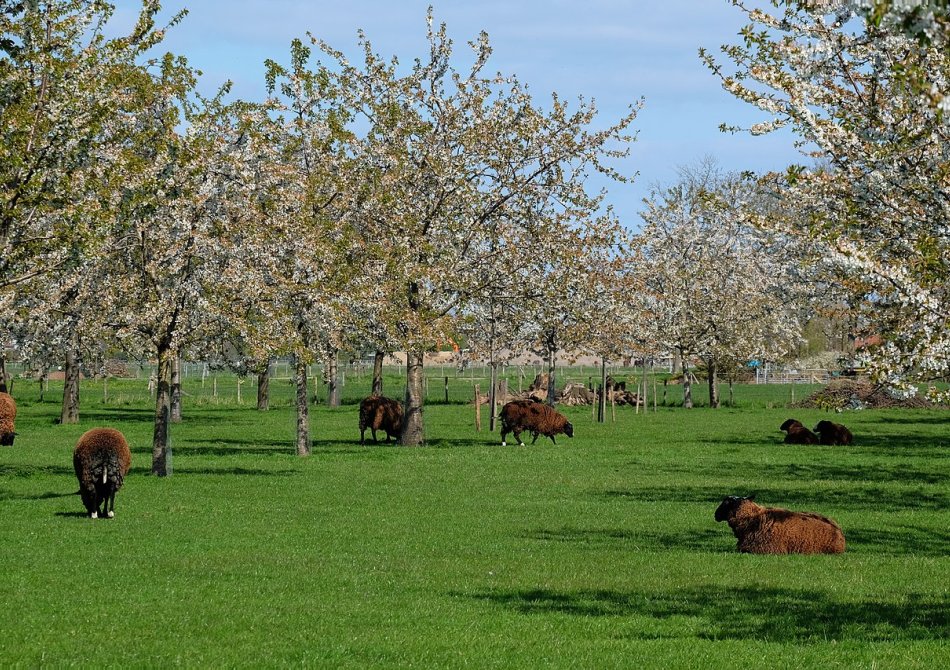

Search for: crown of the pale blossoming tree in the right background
xmin=632 ymin=160 xmax=802 ymax=406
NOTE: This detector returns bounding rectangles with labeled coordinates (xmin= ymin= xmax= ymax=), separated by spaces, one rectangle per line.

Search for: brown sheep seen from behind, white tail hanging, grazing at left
xmin=73 ymin=428 xmax=132 ymax=519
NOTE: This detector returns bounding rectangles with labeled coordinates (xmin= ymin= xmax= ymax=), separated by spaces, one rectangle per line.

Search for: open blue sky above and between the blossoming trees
xmin=115 ymin=0 xmax=805 ymax=227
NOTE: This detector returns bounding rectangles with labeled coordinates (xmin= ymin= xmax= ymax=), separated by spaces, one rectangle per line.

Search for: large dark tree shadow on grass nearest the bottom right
xmin=473 ymin=586 xmax=950 ymax=642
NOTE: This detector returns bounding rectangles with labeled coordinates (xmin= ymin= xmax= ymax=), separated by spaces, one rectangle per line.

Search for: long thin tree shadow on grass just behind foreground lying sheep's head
xmin=593 ymin=482 xmax=950 ymax=517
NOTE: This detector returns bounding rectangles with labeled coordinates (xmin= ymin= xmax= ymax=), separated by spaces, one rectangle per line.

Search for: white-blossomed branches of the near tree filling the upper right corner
xmin=705 ymin=2 xmax=950 ymax=400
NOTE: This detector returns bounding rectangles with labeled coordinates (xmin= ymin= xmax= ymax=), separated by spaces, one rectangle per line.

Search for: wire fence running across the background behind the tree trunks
xmin=0 ymin=360 xmax=844 ymax=407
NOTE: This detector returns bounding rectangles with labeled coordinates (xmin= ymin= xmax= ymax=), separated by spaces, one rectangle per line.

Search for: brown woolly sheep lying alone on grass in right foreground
xmin=716 ymin=496 xmax=844 ymax=554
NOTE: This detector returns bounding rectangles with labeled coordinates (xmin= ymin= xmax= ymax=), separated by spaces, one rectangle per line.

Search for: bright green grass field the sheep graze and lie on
xmin=0 ymin=382 xmax=950 ymax=669
